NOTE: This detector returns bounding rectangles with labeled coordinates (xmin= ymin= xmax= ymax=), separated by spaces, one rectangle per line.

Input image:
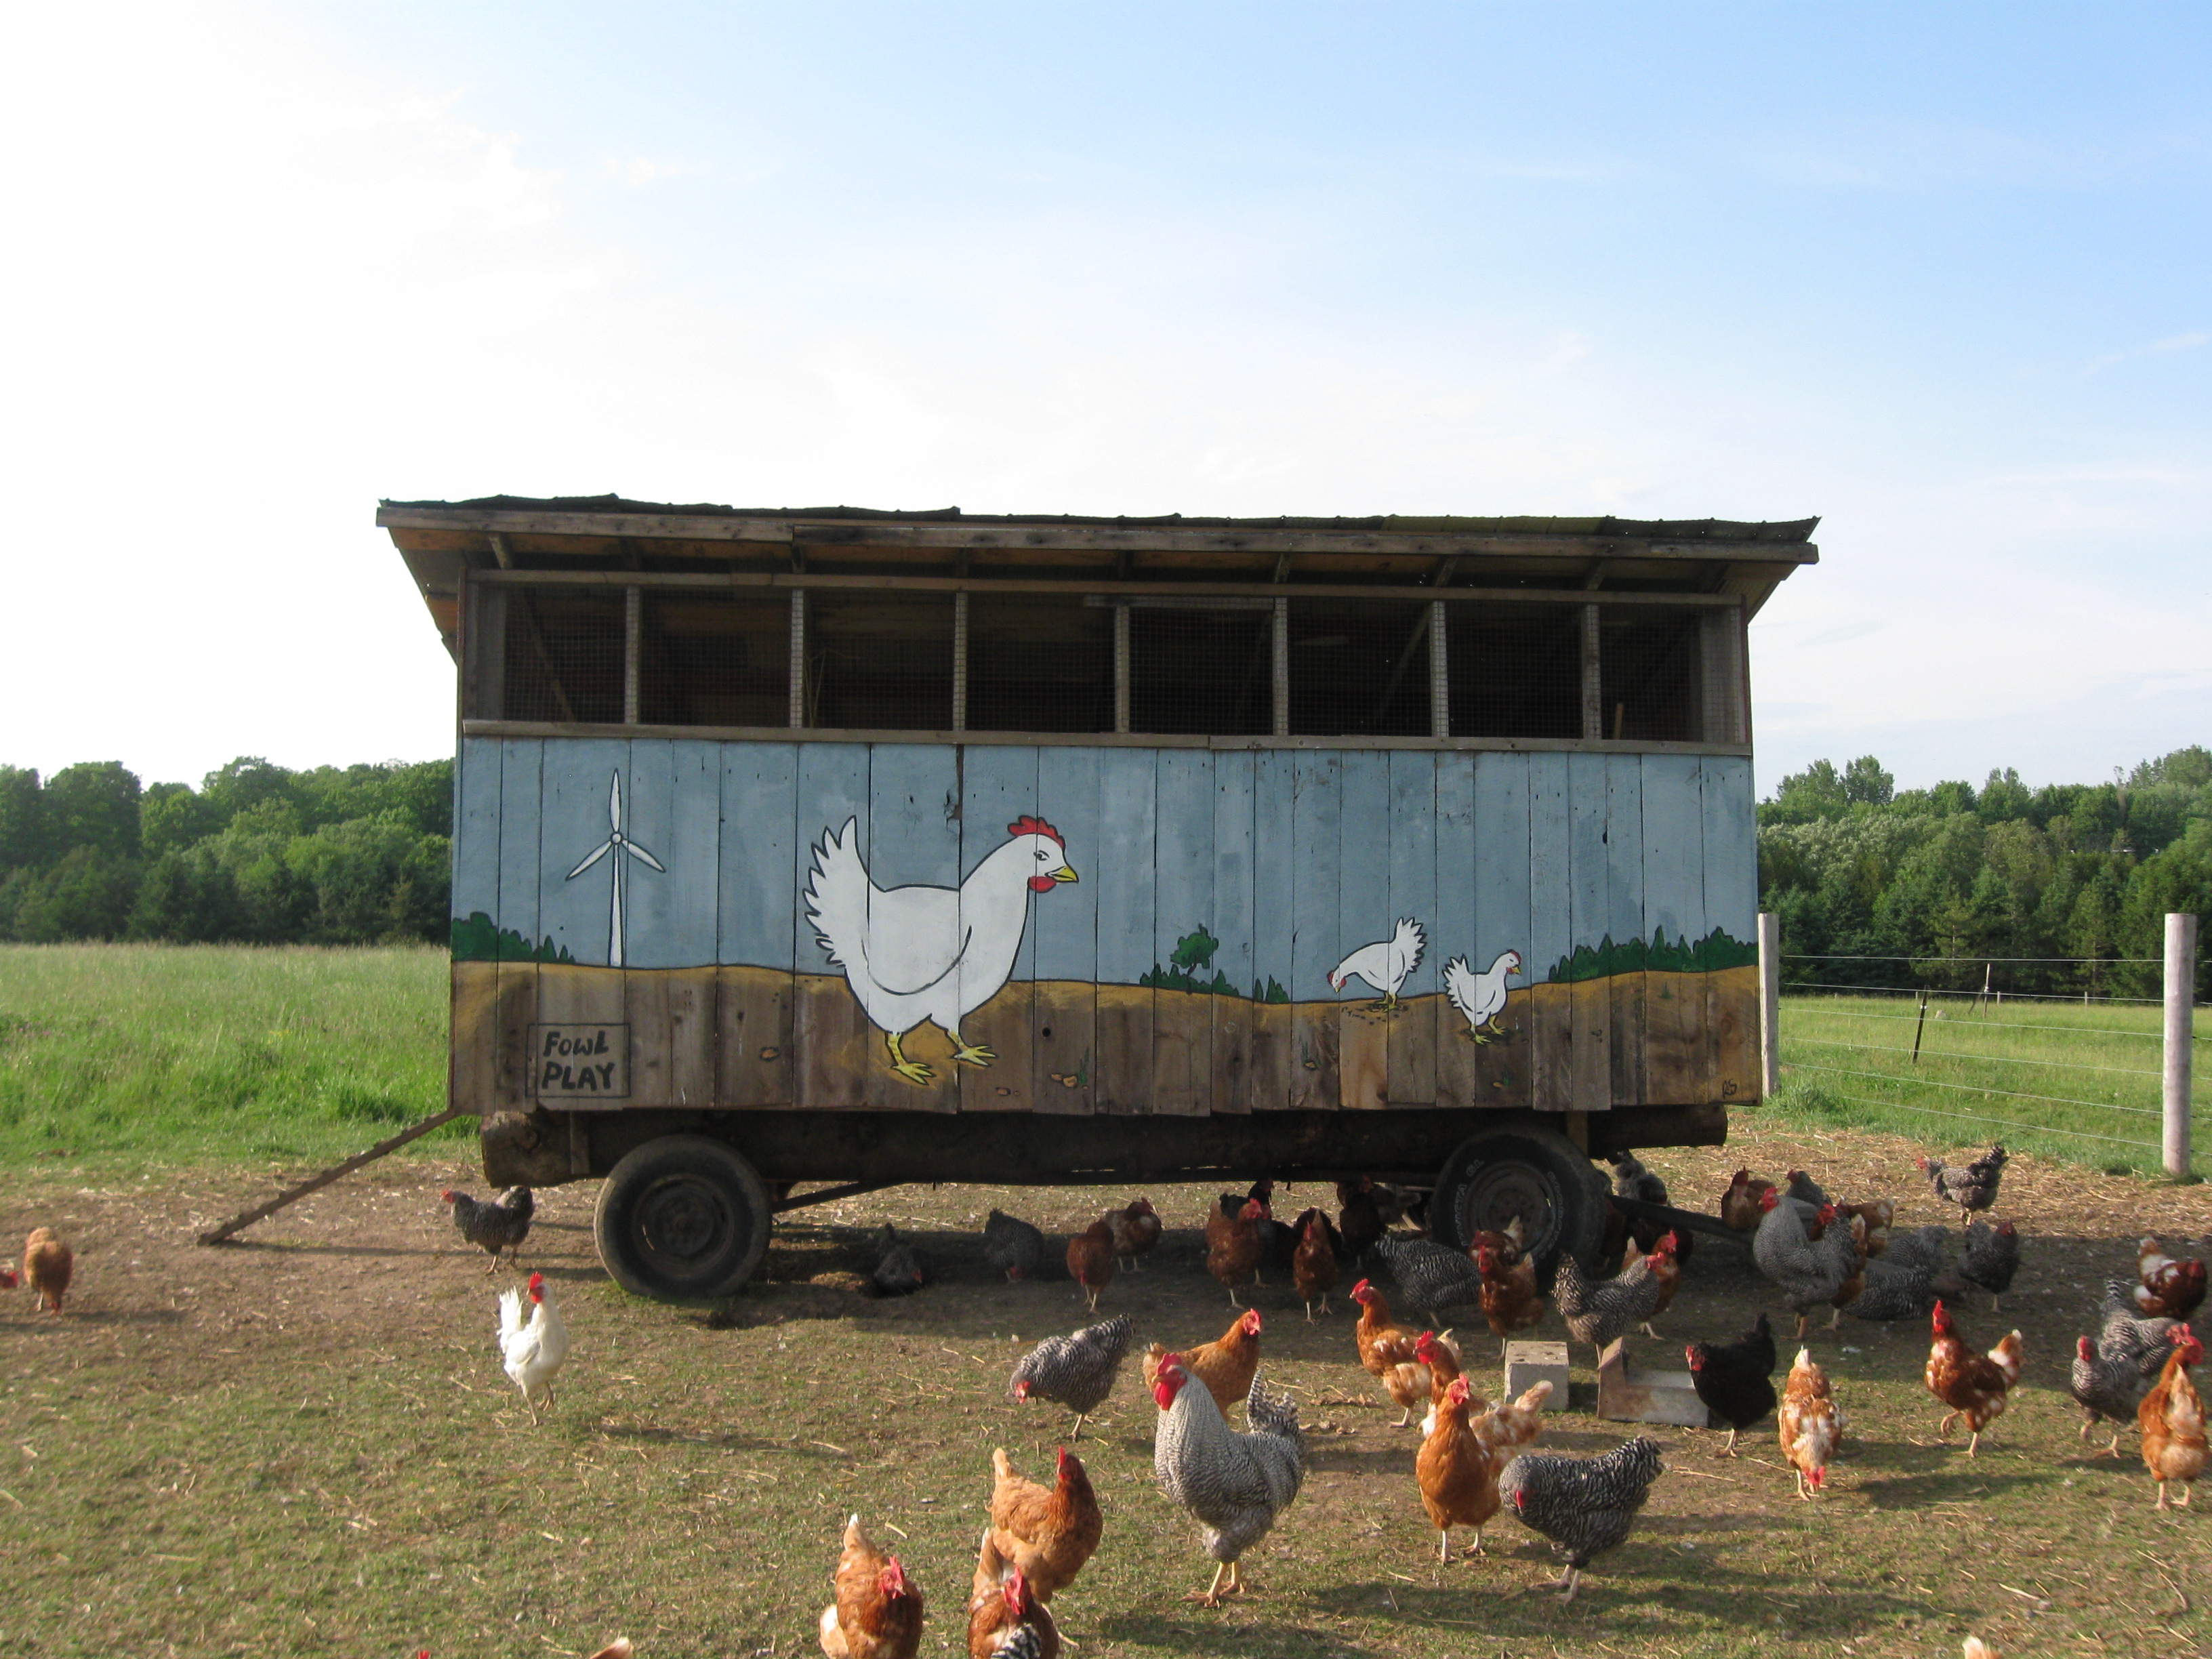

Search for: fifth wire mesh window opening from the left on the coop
xmin=1132 ymin=600 xmax=1274 ymax=737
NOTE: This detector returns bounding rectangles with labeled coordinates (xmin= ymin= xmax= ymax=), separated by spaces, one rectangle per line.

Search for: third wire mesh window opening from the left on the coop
xmin=805 ymin=588 xmax=954 ymax=732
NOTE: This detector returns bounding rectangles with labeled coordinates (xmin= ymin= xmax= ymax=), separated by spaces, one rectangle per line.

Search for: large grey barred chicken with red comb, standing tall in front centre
xmin=1153 ymin=1354 xmax=1305 ymax=1606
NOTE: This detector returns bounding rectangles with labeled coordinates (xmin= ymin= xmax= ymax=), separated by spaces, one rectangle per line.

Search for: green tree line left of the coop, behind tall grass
xmin=0 ymin=756 xmax=453 ymax=945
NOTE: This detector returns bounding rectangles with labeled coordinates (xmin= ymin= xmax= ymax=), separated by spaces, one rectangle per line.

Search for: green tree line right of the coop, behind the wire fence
xmin=1759 ymin=745 xmax=2212 ymax=1000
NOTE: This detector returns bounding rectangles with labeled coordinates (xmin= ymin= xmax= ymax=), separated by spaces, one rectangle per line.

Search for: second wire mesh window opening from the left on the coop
xmin=637 ymin=588 xmax=792 ymax=726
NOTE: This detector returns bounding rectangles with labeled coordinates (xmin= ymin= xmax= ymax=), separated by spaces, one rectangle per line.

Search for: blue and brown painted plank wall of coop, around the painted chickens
xmin=451 ymin=739 xmax=1757 ymax=1113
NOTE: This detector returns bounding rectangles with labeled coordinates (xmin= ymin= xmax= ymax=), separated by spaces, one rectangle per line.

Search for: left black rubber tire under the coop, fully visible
xmin=590 ymin=1134 xmax=770 ymax=1303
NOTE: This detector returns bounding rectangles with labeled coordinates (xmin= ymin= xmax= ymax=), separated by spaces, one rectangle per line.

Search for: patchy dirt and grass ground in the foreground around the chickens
xmin=0 ymin=1117 xmax=2212 ymax=1659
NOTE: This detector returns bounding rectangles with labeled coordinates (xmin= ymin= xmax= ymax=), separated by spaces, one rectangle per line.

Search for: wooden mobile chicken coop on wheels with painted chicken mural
xmin=376 ymin=497 xmax=1816 ymax=1296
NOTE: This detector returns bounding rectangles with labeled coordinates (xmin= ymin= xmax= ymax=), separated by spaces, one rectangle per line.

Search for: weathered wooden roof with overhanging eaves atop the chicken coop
xmin=376 ymin=495 xmax=1820 ymax=663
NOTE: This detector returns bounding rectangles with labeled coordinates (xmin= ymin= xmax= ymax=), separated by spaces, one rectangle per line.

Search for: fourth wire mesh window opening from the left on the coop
xmin=966 ymin=593 xmax=1113 ymax=732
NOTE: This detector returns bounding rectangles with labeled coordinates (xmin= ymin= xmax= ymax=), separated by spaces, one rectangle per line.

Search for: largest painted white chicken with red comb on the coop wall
xmin=807 ymin=816 xmax=1075 ymax=1086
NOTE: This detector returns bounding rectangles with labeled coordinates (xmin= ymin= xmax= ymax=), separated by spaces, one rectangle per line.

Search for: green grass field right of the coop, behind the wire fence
xmin=1771 ymin=996 xmax=2212 ymax=1172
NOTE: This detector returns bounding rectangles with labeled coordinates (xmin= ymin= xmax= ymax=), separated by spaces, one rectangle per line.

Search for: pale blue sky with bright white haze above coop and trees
xmin=0 ymin=5 xmax=2212 ymax=787
